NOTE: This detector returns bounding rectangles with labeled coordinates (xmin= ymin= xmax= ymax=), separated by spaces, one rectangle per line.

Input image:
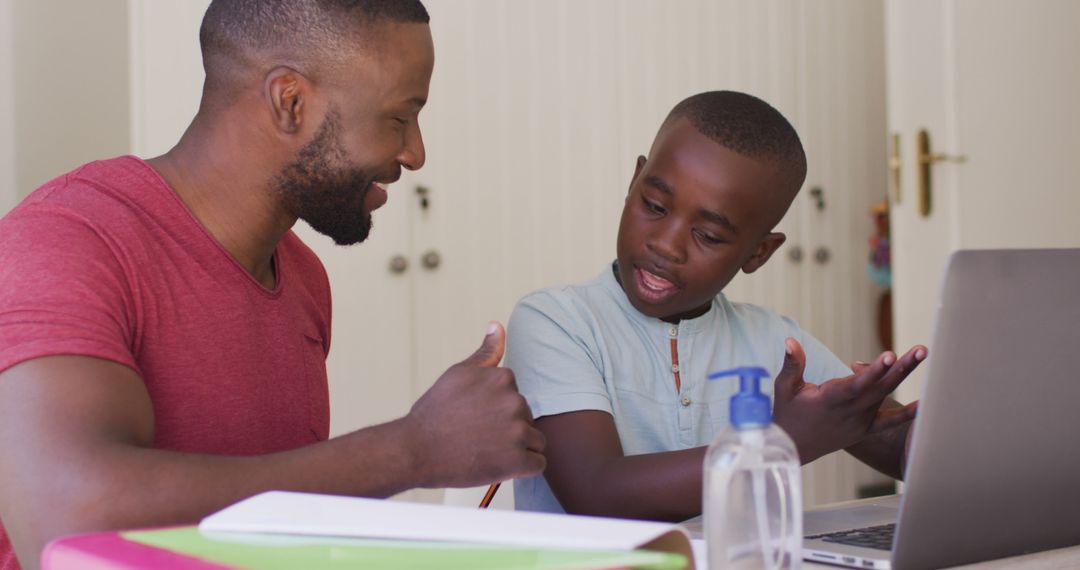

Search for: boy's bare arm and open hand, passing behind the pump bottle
xmin=536 ymin=339 xmax=926 ymax=520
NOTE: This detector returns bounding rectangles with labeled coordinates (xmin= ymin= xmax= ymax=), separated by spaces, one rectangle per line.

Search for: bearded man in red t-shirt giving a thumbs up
xmin=0 ymin=0 xmax=544 ymax=570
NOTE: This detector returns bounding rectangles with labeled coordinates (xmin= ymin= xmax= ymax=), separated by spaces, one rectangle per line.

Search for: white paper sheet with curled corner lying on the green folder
xmin=199 ymin=491 xmax=692 ymax=557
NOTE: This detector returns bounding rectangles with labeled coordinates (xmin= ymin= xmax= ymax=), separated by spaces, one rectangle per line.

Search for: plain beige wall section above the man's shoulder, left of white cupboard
xmin=13 ymin=0 xmax=131 ymax=195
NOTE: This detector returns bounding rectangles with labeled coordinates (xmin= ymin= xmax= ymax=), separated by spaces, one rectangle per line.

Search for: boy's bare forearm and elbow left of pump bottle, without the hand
xmin=536 ymin=410 xmax=705 ymax=521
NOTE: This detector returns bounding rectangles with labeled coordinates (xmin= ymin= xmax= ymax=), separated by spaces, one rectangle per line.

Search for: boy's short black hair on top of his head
xmin=664 ymin=91 xmax=807 ymax=194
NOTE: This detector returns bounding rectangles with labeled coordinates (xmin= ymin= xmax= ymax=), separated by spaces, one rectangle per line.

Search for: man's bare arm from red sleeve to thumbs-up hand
xmin=0 ymin=328 xmax=544 ymax=568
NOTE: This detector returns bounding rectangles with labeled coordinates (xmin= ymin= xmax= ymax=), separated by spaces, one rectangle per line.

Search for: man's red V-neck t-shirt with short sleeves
xmin=0 ymin=157 xmax=330 ymax=570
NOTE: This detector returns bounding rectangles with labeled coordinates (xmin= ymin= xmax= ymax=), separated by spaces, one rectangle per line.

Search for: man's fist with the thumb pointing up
xmin=405 ymin=323 xmax=545 ymax=487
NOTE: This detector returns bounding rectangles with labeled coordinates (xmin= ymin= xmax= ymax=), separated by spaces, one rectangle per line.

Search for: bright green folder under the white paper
xmin=122 ymin=527 xmax=688 ymax=570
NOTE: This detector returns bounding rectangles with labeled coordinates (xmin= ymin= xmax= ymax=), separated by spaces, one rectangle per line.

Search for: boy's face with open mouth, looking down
xmin=618 ymin=118 xmax=791 ymax=322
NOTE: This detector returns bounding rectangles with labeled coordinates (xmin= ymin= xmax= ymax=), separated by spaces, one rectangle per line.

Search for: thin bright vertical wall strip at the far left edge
xmin=0 ymin=0 xmax=18 ymax=215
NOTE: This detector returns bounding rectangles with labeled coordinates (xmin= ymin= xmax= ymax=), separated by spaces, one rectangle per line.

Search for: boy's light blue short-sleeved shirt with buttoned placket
xmin=504 ymin=266 xmax=851 ymax=513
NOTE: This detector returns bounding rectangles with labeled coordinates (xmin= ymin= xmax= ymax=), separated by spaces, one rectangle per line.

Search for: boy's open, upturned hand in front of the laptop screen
xmin=772 ymin=338 xmax=927 ymax=463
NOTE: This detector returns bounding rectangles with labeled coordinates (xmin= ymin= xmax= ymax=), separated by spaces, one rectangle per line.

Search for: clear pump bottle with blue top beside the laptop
xmin=704 ymin=367 xmax=802 ymax=570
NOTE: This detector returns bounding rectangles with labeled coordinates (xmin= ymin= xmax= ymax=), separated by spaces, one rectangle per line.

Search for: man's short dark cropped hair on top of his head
xmin=199 ymin=0 xmax=430 ymax=94
